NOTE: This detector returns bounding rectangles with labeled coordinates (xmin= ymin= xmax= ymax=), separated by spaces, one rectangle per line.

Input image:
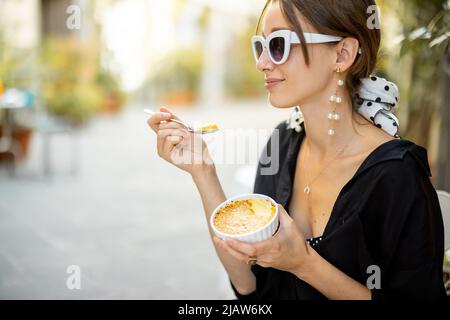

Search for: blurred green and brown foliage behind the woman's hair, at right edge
xmin=391 ymin=0 xmax=450 ymax=146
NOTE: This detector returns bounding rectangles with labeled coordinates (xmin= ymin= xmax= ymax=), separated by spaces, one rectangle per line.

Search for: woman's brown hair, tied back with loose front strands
xmin=256 ymin=0 xmax=381 ymax=109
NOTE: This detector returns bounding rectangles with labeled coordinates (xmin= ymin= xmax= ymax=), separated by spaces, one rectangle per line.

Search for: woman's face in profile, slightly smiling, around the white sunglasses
xmin=257 ymin=1 xmax=336 ymax=108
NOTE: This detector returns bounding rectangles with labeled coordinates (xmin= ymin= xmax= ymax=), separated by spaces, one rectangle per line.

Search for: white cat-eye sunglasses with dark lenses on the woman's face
xmin=252 ymin=30 xmax=343 ymax=64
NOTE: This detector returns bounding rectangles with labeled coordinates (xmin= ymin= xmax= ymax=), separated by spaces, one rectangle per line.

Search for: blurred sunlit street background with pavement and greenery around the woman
xmin=0 ymin=0 xmax=450 ymax=299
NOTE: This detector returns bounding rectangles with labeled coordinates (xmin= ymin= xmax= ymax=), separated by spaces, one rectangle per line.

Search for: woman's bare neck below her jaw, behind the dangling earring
xmin=300 ymin=93 xmax=356 ymax=159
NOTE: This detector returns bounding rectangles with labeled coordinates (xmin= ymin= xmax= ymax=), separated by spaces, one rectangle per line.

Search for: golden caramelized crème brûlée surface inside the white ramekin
xmin=214 ymin=199 xmax=276 ymax=234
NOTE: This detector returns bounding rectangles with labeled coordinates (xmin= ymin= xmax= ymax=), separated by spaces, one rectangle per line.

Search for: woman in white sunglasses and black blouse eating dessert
xmin=148 ymin=0 xmax=445 ymax=299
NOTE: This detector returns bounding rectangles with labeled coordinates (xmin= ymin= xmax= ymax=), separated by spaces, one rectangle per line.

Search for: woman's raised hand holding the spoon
xmin=147 ymin=107 xmax=213 ymax=176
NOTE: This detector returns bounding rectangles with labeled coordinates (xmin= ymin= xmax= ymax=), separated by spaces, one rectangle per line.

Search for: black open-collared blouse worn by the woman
xmin=230 ymin=122 xmax=445 ymax=299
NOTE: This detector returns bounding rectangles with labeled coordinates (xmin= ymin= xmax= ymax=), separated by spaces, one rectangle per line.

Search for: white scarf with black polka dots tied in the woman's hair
xmin=287 ymin=77 xmax=400 ymax=138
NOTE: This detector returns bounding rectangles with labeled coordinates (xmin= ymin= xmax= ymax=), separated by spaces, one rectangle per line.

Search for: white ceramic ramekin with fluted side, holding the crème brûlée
xmin=210 ymin=193 xmax=279 ymax=243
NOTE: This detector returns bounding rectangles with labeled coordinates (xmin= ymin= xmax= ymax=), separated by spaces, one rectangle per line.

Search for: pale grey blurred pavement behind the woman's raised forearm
xmin=0 ymin=101 xmax=289 ymax=299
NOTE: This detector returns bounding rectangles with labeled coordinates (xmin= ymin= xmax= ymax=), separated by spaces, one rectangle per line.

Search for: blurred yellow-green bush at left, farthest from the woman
xmin=41 ymin=38 xmax=124 ymax=124
